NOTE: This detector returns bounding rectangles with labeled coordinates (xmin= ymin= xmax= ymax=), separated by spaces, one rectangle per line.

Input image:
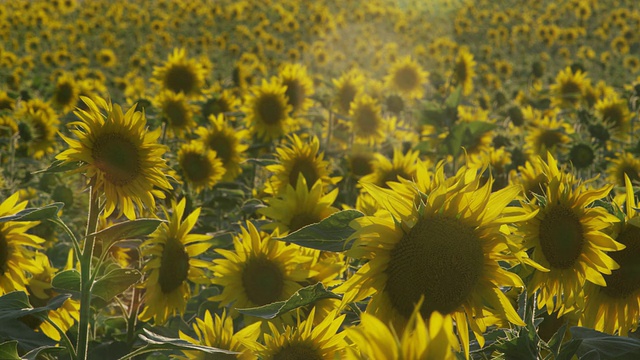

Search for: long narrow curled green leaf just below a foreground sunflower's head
xmin=236 ymin=283 xmax=340 ymax=319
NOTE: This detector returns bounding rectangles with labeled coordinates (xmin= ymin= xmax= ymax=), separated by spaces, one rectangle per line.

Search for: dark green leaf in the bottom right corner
xmin=571 ymin=326 xmax=640 ymax=360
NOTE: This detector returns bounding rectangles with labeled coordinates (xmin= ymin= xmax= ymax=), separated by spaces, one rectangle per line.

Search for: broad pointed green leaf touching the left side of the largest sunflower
xmin=275 ymin=210 xmax=364 ymax=252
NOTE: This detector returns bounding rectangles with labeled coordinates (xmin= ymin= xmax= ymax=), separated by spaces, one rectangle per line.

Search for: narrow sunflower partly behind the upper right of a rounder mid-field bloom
xmin=278 ymin=64 xmax=314 ymax=114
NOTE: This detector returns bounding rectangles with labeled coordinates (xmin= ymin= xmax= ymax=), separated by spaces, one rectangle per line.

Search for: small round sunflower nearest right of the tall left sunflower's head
xmin=178 ymin=141 xmax=226 ymax=193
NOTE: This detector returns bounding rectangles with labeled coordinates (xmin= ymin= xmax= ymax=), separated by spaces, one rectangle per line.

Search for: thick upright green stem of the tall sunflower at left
xmin=77 ymin=186 xmax=100 ymax=360
